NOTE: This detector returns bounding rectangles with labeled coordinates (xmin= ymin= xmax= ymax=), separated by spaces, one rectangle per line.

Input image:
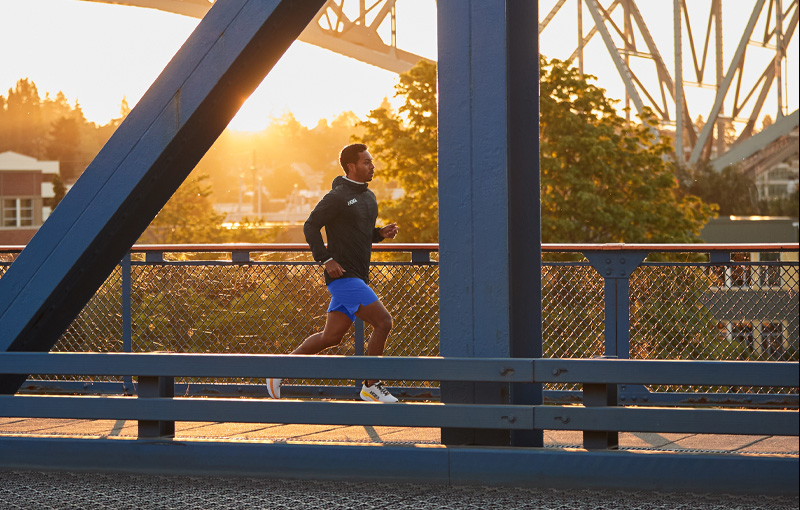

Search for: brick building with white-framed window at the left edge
xmin=0 ymin=151 xmax=58 ymax=245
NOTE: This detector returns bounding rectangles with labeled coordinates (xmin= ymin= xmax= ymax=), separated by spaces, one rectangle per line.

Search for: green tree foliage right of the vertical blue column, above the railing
xmin=539 ymin=57 xmax=713 ymax=243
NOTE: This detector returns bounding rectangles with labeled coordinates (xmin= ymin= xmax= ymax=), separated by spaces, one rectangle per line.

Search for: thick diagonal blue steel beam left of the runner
xmin=0 ymin=0 xmax=324 ymax=394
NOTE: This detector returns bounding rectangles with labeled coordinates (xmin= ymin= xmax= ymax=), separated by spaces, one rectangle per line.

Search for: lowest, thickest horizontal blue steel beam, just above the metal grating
xmin=0 ymin=437 xmax=800 ymax=496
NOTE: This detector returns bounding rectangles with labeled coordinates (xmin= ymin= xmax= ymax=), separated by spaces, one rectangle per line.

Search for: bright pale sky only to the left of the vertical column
xmin=0 ymin=0 xmax=436 ymax=131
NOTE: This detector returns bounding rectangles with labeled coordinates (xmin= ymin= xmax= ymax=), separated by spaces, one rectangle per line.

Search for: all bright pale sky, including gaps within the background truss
xmin=0 ymin=0 xmax=798 ymax=131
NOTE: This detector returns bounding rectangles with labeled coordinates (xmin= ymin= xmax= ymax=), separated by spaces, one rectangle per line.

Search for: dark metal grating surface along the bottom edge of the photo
xmin=0 ymin=470 xmax=798 ymax=510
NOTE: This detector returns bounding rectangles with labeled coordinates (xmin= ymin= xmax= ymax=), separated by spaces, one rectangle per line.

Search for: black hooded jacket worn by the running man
xmin=303 ymin=175 xmax=383 ymax=285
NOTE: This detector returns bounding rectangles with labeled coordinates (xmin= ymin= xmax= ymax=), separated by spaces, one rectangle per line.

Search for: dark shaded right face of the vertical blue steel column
xmin=506 ymin=0 xmax=544 ymax=446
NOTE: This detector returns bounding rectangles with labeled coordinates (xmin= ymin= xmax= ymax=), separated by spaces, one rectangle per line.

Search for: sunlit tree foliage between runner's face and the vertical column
xmin=361 ymin=60 xmax=439 ymax=242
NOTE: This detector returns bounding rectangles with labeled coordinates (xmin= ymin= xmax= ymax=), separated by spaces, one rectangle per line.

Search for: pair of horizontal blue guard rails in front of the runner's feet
xmin=0 ymin=352 xmax=800 ymax=436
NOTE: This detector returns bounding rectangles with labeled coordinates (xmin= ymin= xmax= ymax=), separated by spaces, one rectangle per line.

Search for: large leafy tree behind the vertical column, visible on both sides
xmin=362 ymin=58 xmax=713 ymax=243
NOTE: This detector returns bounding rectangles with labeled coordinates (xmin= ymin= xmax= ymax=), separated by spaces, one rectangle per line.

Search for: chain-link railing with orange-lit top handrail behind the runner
xmin=0 ymin=244 xmax=800 ymax=407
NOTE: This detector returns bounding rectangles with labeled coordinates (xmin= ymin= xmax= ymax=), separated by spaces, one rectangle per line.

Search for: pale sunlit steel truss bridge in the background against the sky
xmin=76 ymin=0 xmax=800 ymax=167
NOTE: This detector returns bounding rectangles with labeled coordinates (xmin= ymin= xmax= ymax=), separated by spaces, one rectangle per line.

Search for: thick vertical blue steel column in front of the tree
xmin=438 ymin=0 xmax=541 ymax=445
